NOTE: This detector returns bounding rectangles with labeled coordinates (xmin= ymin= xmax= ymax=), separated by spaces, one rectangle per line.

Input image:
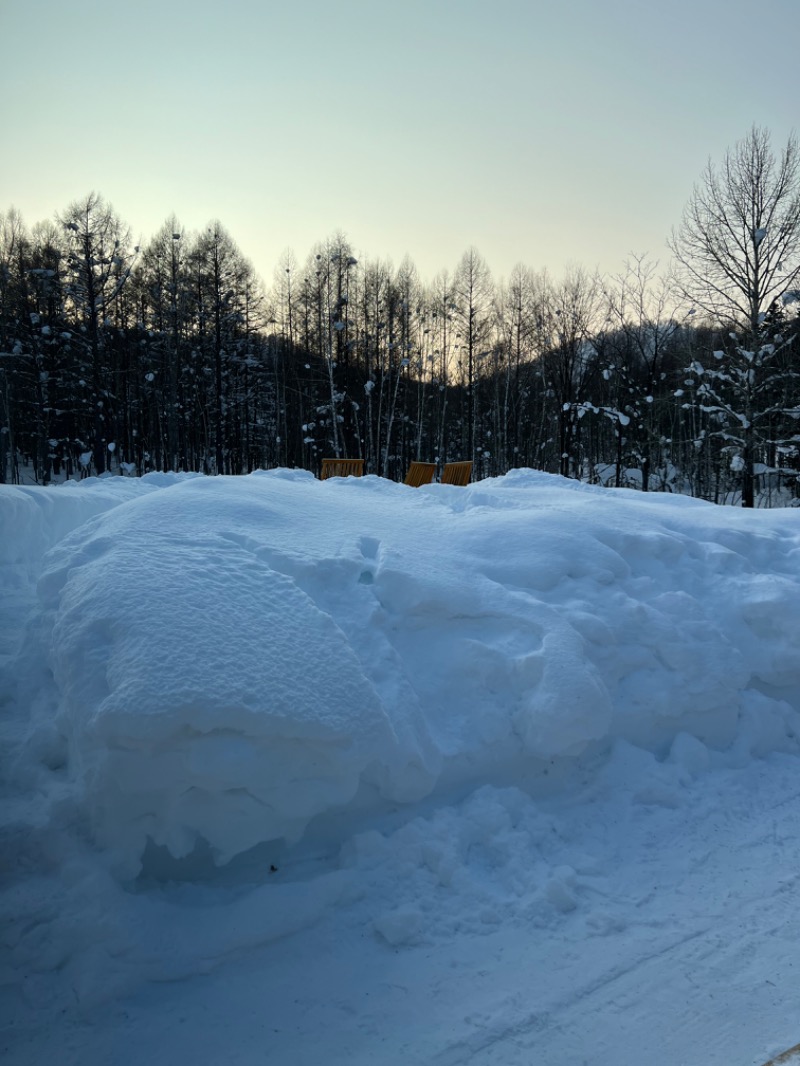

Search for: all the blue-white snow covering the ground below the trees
xmin=0 ymin=471 xmax=800 ymax=1066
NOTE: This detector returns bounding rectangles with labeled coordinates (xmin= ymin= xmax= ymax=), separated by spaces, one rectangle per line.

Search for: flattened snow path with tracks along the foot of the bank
xmin=3 ymin=756 xmax=800 ymax=1066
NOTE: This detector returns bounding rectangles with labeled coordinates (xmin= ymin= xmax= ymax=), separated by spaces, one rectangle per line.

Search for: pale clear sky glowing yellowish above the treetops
xmin=0 ymin=0 xmax=800 ymax=285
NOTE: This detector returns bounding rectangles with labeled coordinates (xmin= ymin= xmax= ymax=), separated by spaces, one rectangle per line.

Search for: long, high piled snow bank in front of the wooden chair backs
xmin=26 ymin=471 xmax=800 ymax=874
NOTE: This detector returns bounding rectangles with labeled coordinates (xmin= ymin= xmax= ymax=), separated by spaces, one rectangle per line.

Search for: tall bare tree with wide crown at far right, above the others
xmin=671 ymin=127 xmax=800 ymax=507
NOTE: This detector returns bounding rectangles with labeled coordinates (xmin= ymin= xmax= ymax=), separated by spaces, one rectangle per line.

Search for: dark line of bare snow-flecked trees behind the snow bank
xmin=0 ymin=134 xmax=800 ymax=504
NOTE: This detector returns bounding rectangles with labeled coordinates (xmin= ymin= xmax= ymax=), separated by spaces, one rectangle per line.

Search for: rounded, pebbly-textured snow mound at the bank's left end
xmin=41 ymin=490 xmax=428 ymax=872
